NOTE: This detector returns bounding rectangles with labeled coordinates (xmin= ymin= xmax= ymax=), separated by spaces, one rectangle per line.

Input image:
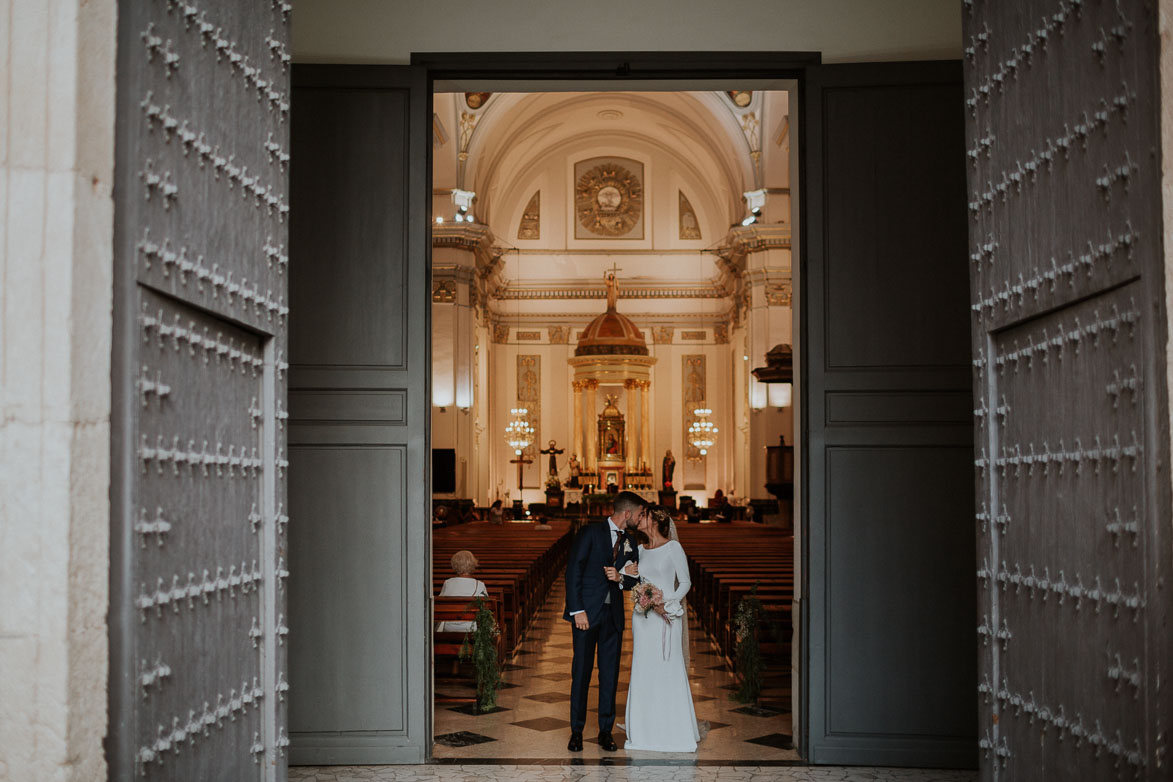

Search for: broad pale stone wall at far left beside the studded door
xmin=0 ymin=0 xmax=115 ymax=782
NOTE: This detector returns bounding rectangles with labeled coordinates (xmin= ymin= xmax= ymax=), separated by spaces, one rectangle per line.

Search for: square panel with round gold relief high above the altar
xmin=575 ymin=157 xmax=644 ymax=239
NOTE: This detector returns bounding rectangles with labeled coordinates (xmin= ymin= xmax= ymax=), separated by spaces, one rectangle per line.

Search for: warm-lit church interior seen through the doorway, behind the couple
xmin=422 ymin=89 xmax=799 ymax=762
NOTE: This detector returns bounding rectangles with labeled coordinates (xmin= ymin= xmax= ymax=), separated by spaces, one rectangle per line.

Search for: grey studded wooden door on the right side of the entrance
xmin=964 ymin=0 xmax=1169 ymax=781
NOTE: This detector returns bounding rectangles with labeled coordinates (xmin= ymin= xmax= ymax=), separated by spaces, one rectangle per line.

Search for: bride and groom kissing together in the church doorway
xmin=563 ymin=491 xmax=700 ymax=753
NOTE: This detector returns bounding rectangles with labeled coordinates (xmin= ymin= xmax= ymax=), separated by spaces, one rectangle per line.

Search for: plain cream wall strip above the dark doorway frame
xmin=293 ymin=0 xmax=962 ymax=62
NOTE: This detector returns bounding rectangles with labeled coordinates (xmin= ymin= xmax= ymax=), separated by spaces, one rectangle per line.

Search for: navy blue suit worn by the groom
xmin=562 ymin=522 xmax=639 ymax=733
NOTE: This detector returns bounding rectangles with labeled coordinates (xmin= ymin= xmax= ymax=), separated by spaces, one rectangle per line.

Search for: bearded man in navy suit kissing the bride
xmin=563 ymin=491 xmax=647 ymax=753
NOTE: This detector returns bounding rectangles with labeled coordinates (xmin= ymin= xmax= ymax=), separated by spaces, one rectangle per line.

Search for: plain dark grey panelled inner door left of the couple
xmin=289 ymin=66 xmax=432 ymax=764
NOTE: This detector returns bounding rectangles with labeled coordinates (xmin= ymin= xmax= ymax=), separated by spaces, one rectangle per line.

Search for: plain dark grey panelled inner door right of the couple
xmin=800 ymin=62 xmax=977 ymax=767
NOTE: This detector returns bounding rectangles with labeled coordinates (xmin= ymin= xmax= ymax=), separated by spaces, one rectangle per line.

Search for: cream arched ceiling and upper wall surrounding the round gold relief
xmin=433 ymin=90 xmax=789 ymax=314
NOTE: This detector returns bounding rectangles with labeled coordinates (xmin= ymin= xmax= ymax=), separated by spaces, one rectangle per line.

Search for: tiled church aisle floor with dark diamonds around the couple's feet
xmin=433 ymin=580 xmax=798 ymax=763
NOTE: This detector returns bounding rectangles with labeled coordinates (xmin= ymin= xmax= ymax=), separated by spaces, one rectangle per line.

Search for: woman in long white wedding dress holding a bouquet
xmin=624 ymin=505 xmax=700 ymax=753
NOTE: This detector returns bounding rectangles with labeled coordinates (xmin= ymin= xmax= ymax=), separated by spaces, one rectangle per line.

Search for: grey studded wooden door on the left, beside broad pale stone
xmin=108 ymin=0 xmax=291 ymax=781
